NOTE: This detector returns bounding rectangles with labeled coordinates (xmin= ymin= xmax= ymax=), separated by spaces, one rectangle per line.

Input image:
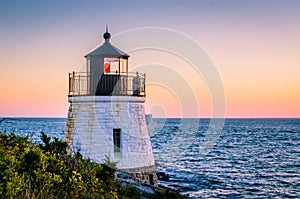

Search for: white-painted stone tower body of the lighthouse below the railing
xmin=67 ymin=99 xmax=155 ymax=169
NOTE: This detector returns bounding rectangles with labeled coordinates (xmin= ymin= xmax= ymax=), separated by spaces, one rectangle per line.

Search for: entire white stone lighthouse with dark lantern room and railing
xmin=65 ymin=29 xmax=157 ymax=185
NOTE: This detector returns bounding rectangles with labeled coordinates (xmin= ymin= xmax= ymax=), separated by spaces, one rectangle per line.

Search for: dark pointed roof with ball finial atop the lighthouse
xmin=84 ymin=29 xmax=129 ymax=58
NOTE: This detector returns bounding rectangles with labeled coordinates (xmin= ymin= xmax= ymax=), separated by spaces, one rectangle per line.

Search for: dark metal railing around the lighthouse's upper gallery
xmin=69 ymin=72 xmax=146 ymax=96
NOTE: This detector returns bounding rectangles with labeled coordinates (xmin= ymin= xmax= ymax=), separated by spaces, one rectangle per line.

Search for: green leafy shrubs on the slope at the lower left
xmin=0 ymin=133 xmax=141 ymax=199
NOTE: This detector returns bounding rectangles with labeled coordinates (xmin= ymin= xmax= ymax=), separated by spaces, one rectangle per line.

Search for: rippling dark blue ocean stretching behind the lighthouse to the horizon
xmin=0 ymin=118 xmax=300 ymax=198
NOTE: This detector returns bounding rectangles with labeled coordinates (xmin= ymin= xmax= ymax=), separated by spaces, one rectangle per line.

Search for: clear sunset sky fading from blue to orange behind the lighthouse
xmin=0 ymin=0 xmax=300 ymax=118
